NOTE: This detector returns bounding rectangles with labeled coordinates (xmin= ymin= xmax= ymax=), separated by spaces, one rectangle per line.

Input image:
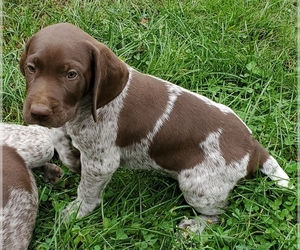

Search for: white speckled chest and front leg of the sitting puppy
xmin=64 ymin=73 xmax=130 ymax=217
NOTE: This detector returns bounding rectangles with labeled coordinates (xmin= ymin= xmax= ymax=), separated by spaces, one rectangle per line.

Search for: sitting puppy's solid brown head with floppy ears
xmin=20 ymin=23 xmax=128 ymax=127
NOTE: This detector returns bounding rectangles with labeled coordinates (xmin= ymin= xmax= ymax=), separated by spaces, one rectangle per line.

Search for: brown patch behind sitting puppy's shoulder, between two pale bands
xmin=116 ymin=71 xmax=168 ymax=147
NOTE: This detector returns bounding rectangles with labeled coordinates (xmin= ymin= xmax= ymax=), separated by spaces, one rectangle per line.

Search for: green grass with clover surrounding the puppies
xmin=2 ymin=0 xmax=298 ymax=250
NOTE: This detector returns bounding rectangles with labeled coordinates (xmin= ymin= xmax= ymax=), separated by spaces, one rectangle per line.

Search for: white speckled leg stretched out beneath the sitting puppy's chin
xmin=0 ymin=123 xmax=81 ymax=173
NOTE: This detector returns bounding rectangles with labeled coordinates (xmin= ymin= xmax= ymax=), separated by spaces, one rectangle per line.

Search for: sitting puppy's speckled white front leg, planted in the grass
xmin=63 ymin=152 xmax=120 ymax=218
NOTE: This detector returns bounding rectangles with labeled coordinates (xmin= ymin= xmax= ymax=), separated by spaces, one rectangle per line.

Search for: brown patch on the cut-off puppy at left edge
xmin=2 ymin=145 xmax=33 ymax=207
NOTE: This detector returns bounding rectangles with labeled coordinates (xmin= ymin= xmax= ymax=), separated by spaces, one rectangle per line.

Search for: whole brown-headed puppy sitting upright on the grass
xmin=20 ymin=23 xmax=289 ymax=231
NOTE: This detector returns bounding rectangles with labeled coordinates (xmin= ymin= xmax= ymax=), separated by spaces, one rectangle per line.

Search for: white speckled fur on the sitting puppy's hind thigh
xmin=178 ymin=129 xmax=249 ymax=215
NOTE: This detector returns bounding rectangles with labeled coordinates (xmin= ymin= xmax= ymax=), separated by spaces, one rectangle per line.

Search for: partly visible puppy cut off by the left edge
xmin=0 ymin=123 xmax=63 ymax=250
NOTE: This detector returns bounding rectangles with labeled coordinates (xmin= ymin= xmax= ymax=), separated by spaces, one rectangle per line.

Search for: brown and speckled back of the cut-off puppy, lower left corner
xmin=0 ymin=145 xmax=38 ymax=250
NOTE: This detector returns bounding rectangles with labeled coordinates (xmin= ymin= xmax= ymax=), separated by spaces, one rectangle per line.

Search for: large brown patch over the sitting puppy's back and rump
xmin=149 ymin=92 xmax=251 ymax=172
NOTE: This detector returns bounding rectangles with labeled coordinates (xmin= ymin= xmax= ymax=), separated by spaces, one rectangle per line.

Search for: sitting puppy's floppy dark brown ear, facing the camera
xmin=88 ymin=40 xmax=129 ymax=122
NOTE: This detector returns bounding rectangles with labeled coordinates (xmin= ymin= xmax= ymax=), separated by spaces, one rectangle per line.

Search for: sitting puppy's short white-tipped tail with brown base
xmin=255 ymin=141 xmax=290 ymax=187
